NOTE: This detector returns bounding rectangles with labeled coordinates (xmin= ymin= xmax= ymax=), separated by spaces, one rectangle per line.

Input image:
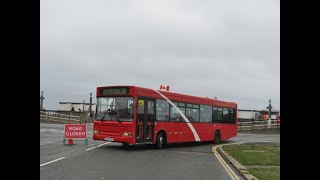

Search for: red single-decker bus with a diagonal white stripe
xmin=93 ymin=86 xmax=238 ymax=149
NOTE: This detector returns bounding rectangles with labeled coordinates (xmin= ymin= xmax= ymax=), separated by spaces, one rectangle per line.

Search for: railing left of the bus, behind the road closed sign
xmin=40 ymin=110 xmax=90 ymax=124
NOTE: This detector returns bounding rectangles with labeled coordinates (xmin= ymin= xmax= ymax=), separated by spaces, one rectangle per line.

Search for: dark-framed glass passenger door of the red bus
xmin=136 ymin=98 xmax=155 ymax=143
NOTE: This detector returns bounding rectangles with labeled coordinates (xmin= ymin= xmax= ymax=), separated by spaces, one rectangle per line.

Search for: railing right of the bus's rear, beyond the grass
xmin=238 ymin=120 xmax=280 ymax=131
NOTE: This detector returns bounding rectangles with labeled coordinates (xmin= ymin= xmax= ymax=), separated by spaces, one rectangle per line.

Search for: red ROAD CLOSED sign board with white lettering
xmin=64 ymin=124 xmax=87 ymax=139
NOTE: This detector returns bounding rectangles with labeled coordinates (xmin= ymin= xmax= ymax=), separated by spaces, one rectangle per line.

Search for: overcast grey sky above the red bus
xmin=40 ymin=0 xmax=280 ymax=110
